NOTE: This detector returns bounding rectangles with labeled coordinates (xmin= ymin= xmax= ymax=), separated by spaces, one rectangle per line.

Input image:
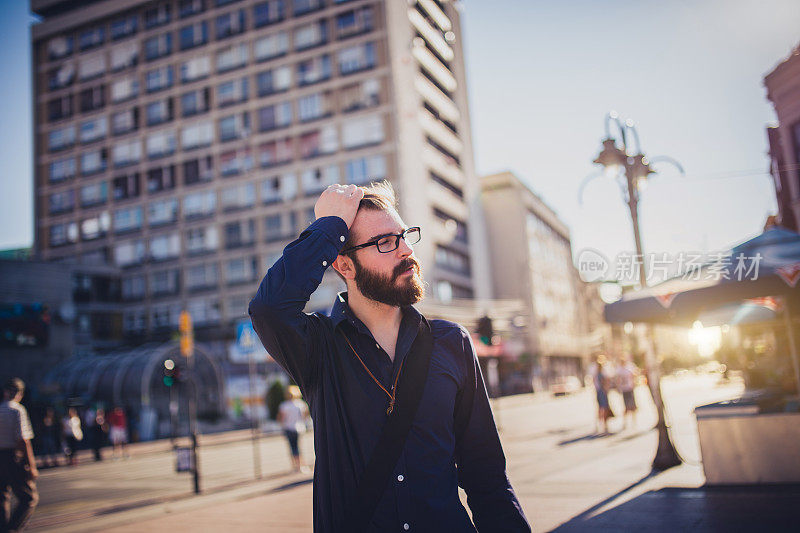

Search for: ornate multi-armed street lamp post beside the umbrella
xmin=593 ymin=112 xmax=683 ymax=471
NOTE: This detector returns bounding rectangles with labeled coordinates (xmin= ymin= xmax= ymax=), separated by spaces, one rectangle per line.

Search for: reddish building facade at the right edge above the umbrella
xmin=764 ymin=48 xmax=800 ymax=231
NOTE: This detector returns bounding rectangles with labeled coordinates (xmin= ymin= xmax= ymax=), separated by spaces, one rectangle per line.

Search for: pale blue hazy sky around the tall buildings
xmin=0 ymin=0 xmax=800 ymax=272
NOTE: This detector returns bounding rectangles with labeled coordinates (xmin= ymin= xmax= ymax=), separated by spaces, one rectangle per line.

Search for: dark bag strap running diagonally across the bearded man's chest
xmin=345 ymin=317 xmax=433 ymax=531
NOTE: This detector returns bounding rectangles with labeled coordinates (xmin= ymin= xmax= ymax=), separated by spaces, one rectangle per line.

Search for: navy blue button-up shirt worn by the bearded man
xmin=249 ymin=217 xmax=530 ymax=532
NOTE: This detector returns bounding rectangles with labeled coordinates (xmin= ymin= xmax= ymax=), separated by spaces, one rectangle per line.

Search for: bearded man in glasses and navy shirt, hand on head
xmin=249 ymin=182 xmax=530 ymax=532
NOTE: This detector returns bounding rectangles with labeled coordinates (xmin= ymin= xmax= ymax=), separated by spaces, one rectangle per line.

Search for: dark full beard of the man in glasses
xmin=353 ymin=256 xmax=425 ymax=307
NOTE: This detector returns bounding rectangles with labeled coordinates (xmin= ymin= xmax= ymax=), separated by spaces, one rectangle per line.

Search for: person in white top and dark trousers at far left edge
xmin=0 ymin=378 xmax=39 ymax=531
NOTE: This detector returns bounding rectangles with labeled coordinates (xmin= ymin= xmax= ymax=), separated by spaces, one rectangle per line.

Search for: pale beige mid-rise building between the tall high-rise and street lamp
xmin=481 ymin=172 xmax=596 ymax=389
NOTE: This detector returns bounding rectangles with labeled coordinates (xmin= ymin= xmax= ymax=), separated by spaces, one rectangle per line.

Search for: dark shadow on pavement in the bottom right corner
xmin=553 ymin=484 xmax=800 ymax=533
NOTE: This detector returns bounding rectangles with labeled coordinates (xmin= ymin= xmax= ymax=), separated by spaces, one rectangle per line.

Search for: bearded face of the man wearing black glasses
xmin=350 ymin=209 xmax=425 ymax=307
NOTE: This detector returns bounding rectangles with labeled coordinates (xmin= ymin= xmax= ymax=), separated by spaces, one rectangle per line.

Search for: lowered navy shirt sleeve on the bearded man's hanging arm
xmin=456 ymin=330 xmax=531 ymax=533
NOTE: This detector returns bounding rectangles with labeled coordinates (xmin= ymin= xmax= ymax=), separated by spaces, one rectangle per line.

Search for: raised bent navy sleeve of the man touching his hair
xmin=249 ymin=217 xmax=348 ymax=395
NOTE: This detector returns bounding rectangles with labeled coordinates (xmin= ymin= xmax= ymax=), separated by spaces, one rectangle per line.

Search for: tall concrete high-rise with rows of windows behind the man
xmin=31 ymin=0 xmax=491 ymax=341
